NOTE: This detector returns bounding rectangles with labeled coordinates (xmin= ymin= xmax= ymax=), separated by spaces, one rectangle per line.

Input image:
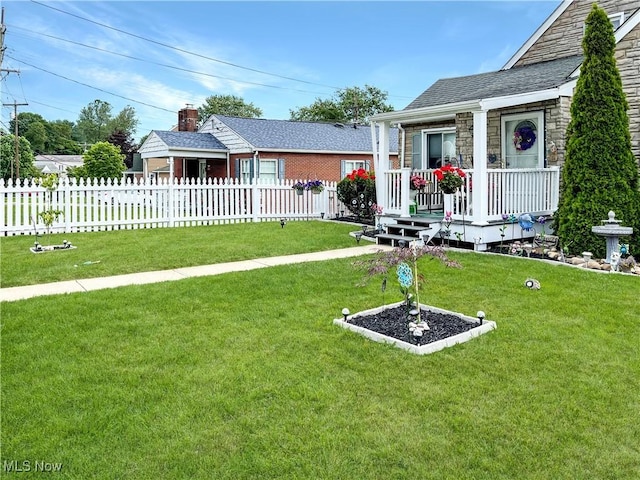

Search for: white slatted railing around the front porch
xmin=379 ymin=167 xmax=560 ymax=222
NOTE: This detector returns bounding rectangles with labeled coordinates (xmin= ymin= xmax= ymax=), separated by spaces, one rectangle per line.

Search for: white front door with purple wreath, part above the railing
xmin=502 ymin=111 xmax=544 ymax=168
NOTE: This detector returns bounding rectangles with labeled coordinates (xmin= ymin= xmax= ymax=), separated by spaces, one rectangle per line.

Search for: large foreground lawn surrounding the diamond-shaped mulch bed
xmin=1 ymin=226 xmax=640 ymax=480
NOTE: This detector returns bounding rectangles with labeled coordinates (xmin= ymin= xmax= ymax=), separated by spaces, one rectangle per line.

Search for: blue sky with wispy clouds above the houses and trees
xmin=0 ymin=0 xmax=561 ymax=139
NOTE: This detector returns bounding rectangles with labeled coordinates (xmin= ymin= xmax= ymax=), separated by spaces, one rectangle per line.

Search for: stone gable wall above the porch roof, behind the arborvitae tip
xmin=515 ymin=0 xmax=640 ymax=66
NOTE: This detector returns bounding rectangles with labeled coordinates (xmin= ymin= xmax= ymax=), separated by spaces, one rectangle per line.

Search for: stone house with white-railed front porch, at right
xmin=372 ymin=0 xmax=640 ymax=250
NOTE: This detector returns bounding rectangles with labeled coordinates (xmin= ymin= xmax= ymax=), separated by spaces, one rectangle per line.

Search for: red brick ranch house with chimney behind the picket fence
xmin=139 ymin=107 xmax=398 ymax=182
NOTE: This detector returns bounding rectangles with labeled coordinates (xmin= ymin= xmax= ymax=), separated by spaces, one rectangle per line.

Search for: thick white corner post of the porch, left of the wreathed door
xmin=471 ymin=110 xmax=489 ymax=225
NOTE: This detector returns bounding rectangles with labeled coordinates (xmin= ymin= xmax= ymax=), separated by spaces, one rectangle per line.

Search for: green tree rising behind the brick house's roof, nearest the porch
xmin=289 ymin=85 xmax=393 ymax=124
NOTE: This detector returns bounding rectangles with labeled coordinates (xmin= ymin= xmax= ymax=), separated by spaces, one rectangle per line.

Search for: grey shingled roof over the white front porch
xmin=404 ymin=55 xmax=582 ymax=110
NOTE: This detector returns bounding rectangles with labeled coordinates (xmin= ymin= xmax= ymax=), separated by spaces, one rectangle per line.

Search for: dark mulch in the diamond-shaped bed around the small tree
xmin=348 ymin=305 xmax=479 ymax=345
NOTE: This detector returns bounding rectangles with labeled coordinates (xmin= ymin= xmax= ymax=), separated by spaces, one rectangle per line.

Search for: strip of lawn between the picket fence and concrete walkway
xmin=0 ymin=221 xmax=365 ymax=288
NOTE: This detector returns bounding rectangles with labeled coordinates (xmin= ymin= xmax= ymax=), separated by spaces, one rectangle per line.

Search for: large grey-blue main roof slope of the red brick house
xmin=215 ymin=115 xmax=398 ymax=153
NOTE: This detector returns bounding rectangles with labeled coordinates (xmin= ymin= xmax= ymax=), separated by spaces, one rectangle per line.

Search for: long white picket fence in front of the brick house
xmin=0 ymin=178 xmax=344 ymax=236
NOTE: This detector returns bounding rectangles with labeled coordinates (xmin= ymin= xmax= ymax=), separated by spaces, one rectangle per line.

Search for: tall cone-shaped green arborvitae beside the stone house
xmin=554 ymin=4 xmax=640 ymax=258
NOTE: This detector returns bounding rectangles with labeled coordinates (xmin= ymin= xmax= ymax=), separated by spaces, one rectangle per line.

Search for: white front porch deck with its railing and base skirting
xmin=376 ymin=167 xmax=560 ymax=250
